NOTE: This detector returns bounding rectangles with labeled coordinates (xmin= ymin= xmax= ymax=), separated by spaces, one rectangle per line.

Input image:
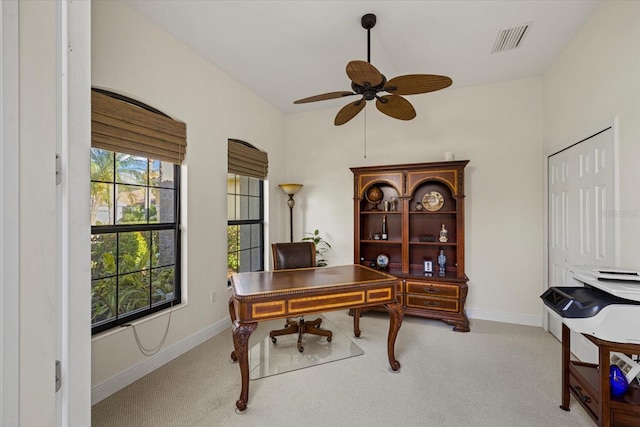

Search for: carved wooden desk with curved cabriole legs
xmin=229 ymin=265 xmax=403 ymax=411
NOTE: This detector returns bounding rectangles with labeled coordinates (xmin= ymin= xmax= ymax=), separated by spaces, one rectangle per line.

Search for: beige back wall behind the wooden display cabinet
xmin=286 ymin=78 xmax=543 ymax=324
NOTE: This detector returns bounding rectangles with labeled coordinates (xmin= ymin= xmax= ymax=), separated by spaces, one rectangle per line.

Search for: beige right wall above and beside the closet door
xmin=543 ymin=1 xmax=640 ymax=268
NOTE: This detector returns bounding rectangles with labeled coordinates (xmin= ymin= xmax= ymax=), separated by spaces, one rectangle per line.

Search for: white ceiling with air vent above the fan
xmin=125 ymin=0 xmax=598 ymax=114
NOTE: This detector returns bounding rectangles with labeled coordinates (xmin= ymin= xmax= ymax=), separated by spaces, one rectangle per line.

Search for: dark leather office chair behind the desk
xmin=269 ymin=242 xmax=333 ymax=352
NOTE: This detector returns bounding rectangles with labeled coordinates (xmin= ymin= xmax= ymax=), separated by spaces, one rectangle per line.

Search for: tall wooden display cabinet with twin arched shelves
xmin=351 ymin=160 xmax=470 ymax=332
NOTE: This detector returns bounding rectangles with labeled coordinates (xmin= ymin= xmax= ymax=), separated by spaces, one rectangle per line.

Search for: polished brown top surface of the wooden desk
xmin=231 ymin=264 xmax=398 ymax=300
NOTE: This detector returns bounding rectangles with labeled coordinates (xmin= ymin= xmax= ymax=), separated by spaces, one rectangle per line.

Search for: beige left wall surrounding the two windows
xmin=91 ymin=1 xmax=285 ymax=387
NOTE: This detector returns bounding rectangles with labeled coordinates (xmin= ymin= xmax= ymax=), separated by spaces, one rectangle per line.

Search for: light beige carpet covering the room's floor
xmin=92 ymin=311 xmax=595 ymax=427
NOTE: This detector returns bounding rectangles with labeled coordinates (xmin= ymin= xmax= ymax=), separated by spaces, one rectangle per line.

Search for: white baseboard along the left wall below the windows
xmin=91 ymin=319 xmax=229 ymax=405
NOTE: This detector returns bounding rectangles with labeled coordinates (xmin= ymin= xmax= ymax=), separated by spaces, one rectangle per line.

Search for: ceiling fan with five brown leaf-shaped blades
xmin=293 ymin=13 xmax=453 ymax=126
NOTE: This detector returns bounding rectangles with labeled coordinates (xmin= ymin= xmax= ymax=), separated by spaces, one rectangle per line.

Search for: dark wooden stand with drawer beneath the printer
xmin=560 ymin=324 xmax=640 ymax=427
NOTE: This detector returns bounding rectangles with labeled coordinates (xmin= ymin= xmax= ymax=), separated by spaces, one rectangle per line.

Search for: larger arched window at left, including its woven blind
xmin=91 ymin=89 xmax=186 ymax=333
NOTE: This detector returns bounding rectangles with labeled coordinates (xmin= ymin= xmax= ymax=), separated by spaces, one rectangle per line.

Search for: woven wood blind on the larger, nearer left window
xmin=91 ymin=90 xmax=187 ymax=165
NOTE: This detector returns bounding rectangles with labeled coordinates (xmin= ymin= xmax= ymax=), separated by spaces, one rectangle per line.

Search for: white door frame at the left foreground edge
xmin=56 ymin=0 xmax=91 ymax=427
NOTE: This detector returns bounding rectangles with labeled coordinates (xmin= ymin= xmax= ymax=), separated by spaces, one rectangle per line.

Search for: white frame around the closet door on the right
xmin=541 ymin=116 xmax=620 ymax=332
